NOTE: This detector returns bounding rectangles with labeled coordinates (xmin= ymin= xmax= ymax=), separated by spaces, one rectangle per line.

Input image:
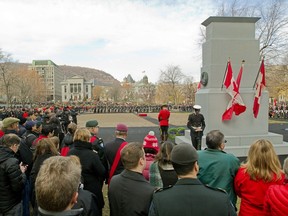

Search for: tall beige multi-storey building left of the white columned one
xmin=29 ymin=60 xmax=63 ymax=102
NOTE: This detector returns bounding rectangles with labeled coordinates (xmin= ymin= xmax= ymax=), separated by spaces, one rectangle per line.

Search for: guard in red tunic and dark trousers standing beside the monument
xmin=158 ymin=105 xmax=170 ymax=142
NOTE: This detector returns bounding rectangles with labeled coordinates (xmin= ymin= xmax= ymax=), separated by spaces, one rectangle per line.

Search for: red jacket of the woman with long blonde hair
xmin=234 ymin=167 xmax=285 ymax=216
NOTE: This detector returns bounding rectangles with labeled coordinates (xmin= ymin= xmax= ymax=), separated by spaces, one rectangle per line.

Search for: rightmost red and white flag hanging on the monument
xmin=253 ymin=59 xmax=266 ymax=118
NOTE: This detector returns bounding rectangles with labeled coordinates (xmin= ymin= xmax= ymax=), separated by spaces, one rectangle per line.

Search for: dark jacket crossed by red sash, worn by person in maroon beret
xmin=104 ymin=138 xmax=126 ymax=175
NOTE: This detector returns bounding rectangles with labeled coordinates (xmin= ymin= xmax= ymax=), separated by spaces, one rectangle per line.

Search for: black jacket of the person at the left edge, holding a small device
xmin=0 ymin=146 xmax=26 ymax=215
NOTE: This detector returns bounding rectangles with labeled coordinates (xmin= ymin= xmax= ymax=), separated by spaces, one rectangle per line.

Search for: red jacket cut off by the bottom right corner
xmin=264 ymin=184 xmax=288 ymax=216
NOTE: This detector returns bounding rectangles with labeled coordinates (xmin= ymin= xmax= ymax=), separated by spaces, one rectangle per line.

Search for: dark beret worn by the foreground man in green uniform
xmin=171 ymin=143 xmax=198 ymax=165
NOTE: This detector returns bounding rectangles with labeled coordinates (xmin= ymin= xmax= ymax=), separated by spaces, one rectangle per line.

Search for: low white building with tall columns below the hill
xmin=61 ymin=76 xmax=92 ymax=102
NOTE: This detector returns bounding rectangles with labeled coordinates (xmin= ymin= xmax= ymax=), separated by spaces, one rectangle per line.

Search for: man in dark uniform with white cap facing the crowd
xmin=187 ymin=105 xmax=206 ymax=150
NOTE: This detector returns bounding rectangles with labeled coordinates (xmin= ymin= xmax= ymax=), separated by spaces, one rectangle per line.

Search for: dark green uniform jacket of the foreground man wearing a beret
xmin=149 ymin=178 xmax=236 ymax=216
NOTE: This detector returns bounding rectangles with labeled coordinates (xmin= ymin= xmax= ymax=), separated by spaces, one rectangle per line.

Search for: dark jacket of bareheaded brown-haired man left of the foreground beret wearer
xmin=108 ymin=169 xmax=154 ymax=216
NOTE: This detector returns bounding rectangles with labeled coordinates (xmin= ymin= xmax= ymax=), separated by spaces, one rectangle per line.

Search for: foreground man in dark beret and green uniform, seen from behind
xmin=149 ymin=143 xmax=236 ymax=216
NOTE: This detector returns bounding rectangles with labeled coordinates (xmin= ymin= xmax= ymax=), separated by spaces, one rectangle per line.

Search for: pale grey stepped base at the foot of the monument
xmin=175 ymin=130 xmax=288 ymax=157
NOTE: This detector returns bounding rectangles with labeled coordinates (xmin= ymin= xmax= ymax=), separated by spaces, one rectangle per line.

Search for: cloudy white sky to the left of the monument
xmin=0 ymin=0 xmax=216 ymax=82
